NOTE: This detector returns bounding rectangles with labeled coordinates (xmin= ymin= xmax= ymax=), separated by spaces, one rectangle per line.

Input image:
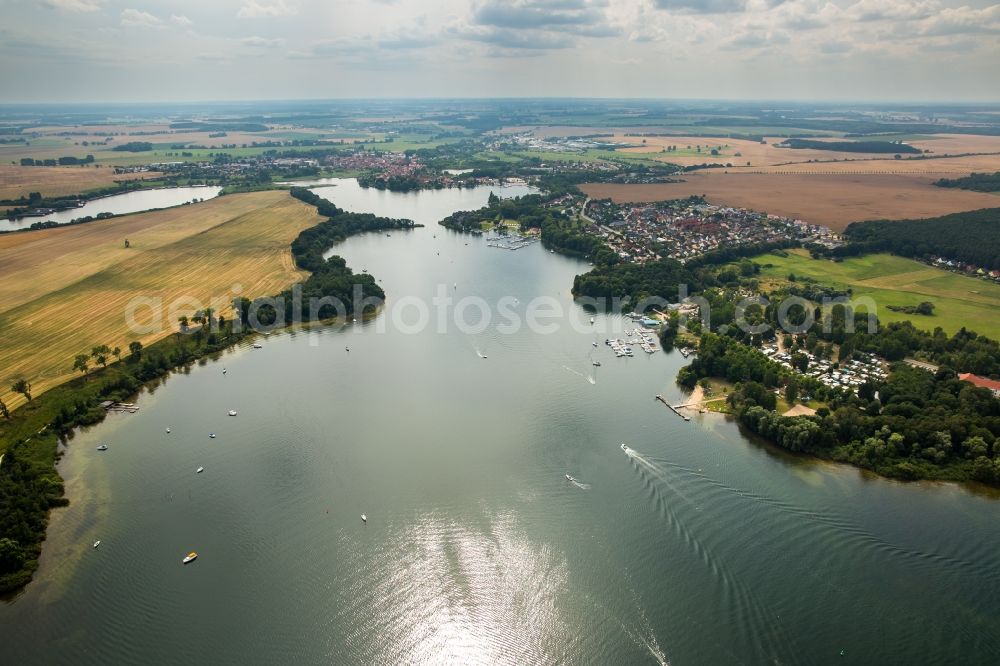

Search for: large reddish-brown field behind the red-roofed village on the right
xmin=581 ymin=171 xmax=1000 ymax=231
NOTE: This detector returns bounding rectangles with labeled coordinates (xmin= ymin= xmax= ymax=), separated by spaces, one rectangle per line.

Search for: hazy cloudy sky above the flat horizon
xmin=0 ymin=0 xmax=1000 ymax=102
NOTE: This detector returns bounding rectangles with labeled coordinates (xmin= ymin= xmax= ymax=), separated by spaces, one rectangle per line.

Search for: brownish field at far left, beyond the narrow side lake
xmin=0 ymin=164 xmax=160 ymax=199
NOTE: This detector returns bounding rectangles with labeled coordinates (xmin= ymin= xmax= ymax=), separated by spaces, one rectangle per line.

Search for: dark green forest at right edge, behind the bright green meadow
xmin=829 ymin=208 xmax=1000 ymax=270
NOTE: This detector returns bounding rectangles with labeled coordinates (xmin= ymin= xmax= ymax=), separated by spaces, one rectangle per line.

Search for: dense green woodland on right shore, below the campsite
xmin=678 ymin=335 xmax=1000 ymax=485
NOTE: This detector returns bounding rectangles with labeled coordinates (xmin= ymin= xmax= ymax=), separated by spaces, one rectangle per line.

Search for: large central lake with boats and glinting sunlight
xmin=0 ymin=187 xmax=1000 ymax=665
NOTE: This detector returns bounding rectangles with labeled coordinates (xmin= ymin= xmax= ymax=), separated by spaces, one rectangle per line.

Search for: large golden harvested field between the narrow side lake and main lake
xmin=0 ymin=191 xmax=320 ymax=405
